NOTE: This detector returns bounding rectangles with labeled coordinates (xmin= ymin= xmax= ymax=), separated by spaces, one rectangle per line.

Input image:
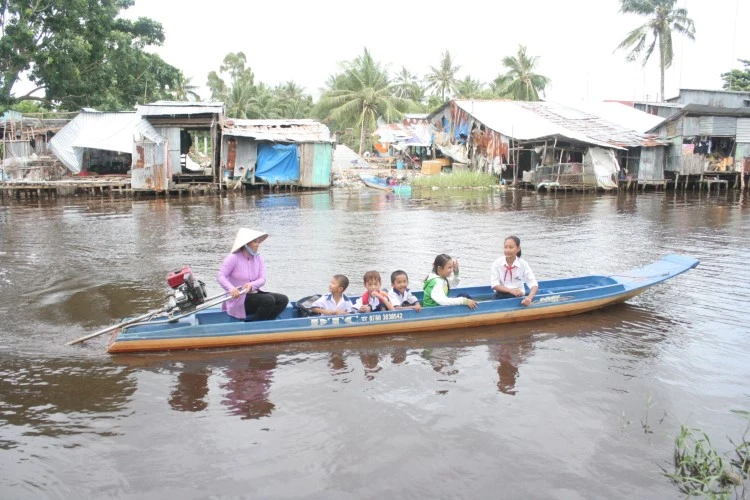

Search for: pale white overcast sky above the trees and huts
xmin=117 ymin=0 xmax=750 ymax=104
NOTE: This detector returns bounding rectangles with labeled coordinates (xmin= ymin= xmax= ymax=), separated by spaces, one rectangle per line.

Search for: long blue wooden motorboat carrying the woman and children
xmin=107 ymin=254 xmax=698 ymax=353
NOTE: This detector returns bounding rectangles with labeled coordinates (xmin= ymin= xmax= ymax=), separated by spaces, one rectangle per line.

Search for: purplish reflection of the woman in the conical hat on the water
xmin=221 ymin=353 xmax=276 ymax=420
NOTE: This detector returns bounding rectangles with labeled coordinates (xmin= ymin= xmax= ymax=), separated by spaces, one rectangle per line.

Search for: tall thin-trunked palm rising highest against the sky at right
xmin=615 ymin=0 xmax=695 ymax=100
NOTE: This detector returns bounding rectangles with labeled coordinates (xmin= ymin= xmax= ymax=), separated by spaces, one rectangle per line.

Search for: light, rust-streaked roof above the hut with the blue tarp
xmin=223 ymin=119 xmax=334 ymax=142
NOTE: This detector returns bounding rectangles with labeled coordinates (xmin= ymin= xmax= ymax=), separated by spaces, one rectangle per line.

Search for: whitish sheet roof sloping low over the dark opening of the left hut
xmin=49 ymin=112 xmax=165 ymax=173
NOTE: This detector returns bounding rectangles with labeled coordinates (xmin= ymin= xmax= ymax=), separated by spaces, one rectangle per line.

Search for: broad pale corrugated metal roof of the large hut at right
xmin=438 ymin=100 xmax=662 ymax=149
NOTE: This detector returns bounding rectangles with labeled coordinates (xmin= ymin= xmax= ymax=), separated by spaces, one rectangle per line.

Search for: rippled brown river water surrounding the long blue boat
xmin=0 ymin=190 xmax=750 ymax=499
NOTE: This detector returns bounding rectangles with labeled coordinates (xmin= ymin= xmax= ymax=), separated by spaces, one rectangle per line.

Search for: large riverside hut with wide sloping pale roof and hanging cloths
xmin=427 ymin=99 xmax=667 ymax=189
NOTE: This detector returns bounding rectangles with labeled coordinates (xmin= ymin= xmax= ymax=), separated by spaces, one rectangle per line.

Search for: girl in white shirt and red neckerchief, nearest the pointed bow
xmin=490 ymin=236 xmax=539 ymax=306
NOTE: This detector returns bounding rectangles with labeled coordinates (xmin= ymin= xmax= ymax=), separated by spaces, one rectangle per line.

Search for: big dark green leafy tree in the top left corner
xmin=0 ymin=0 xmax=181 ymax=109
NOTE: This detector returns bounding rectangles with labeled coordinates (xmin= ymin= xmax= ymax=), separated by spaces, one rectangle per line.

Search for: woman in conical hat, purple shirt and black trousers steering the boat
xmin=217 ymin=227 xmax=289 ymax=321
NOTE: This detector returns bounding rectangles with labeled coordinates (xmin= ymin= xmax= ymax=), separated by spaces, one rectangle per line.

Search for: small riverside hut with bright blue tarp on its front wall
xmin=221 ymin=118 xmax=335 ymax=189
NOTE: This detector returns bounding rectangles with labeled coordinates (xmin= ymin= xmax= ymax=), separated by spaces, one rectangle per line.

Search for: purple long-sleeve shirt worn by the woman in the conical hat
xmin=216 ymin=250 xmax=266 ymax=319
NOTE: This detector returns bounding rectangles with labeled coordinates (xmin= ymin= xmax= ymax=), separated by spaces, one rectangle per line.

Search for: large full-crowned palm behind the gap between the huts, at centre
xmin=317 ymin=48 xmax=412 ymax=154
